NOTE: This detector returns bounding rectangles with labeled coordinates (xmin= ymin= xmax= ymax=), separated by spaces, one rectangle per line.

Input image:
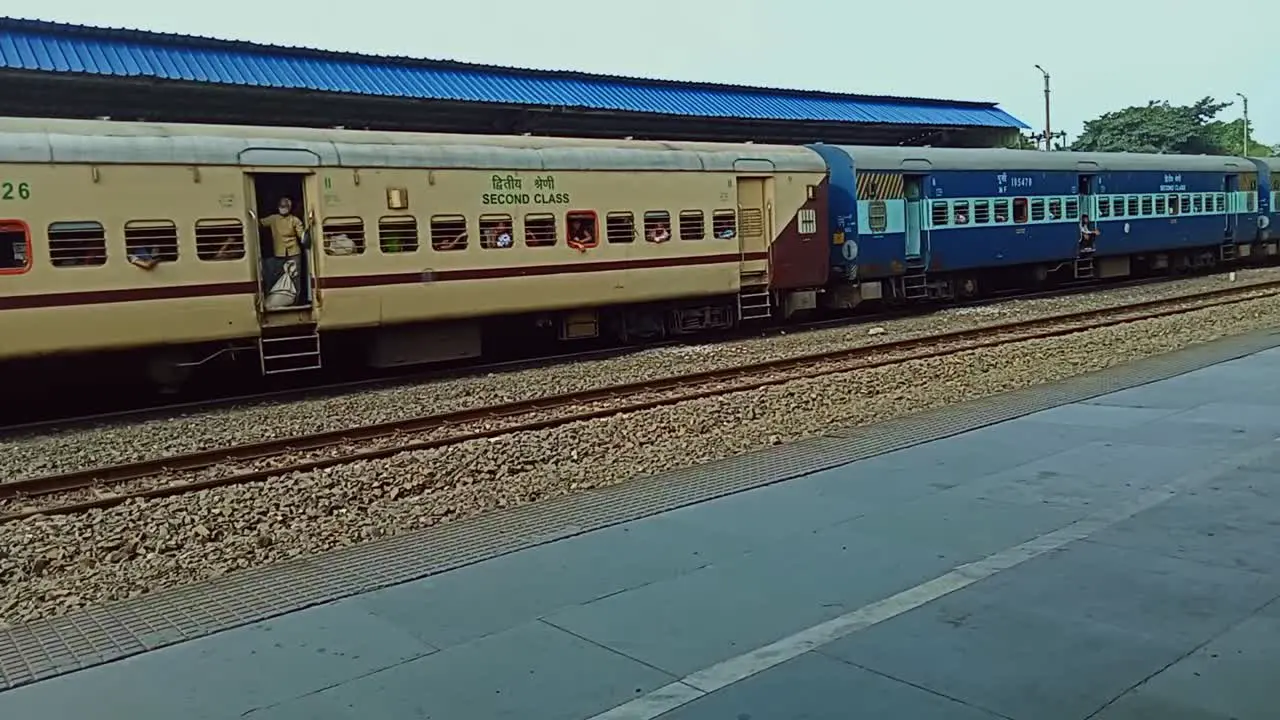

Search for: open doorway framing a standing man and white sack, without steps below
xmin=246 ymin=173 xmax=315 ymax=313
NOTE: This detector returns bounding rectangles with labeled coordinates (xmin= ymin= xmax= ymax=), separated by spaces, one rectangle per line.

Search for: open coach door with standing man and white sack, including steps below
xmin=244 ymin=168 xmax=321 ymax=375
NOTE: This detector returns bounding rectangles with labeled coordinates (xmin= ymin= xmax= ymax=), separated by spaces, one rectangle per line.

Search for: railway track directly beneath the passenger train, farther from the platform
xmin=0 ymin=271 xmax=1218 ymax=438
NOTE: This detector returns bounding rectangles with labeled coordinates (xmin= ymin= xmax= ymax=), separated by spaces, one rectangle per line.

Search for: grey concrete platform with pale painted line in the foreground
xmin=0 ymin=336 xmax=1280 ymax=720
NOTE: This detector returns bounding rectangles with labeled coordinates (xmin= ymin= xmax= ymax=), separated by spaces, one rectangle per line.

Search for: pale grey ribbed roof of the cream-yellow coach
xmin=0 ymin=118 xmax=826 ymax=173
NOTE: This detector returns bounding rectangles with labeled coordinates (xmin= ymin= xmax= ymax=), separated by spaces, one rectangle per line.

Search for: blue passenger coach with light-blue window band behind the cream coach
xmin=810 ymin=145 xmax=1264 ymax=307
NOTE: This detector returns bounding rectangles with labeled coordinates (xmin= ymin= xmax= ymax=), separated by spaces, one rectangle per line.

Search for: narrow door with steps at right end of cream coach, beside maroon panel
xmin=737 ymin=177 xmax=773 ymax=320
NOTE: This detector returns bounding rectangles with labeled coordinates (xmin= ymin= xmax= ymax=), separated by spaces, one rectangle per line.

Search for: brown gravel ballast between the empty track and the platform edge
xmin=0 ymin=283 xmax=1277 ymax=623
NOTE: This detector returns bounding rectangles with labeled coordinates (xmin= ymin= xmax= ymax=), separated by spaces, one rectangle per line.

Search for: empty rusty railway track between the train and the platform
xmin=0 ymin=281 xmax=1280 ymax=523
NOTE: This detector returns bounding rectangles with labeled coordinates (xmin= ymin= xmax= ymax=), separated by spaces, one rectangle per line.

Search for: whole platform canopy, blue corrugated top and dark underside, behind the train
xmin=0 ymin=18 xmax=1028 ymax=146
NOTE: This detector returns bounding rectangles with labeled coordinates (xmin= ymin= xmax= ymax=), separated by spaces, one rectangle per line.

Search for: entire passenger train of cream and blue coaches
xmin=0 ymin=118 xmax=1280 ymax=391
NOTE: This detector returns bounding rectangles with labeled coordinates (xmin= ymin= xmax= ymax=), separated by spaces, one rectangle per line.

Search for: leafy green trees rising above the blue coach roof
xmin=1071 ymin=97 xmax=1271 ymax=155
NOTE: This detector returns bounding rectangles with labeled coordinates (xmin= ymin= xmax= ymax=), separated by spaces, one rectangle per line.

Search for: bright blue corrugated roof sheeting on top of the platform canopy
xmin=0 ymin=18 xmax=1029 ymax=128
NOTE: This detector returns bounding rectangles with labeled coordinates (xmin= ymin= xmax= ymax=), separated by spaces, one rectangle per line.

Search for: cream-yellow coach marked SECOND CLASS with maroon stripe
xmin=0 ymin=118 xmax=829 ymax=386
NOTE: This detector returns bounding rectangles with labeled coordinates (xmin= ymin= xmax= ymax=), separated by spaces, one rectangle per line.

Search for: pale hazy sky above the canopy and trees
xmin=3 ymin=0 xmax=1280 ymax=145
